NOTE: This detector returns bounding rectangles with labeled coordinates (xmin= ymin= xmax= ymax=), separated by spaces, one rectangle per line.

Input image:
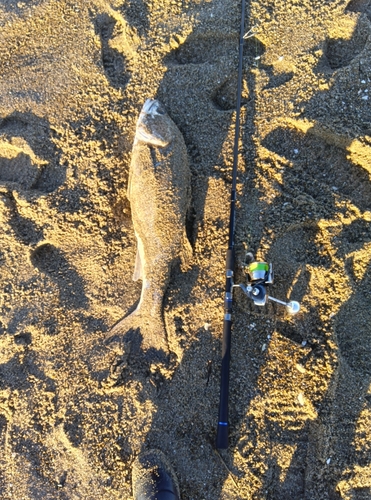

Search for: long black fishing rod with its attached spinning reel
xmin=216 ymin=0 xmax=300 ymax=449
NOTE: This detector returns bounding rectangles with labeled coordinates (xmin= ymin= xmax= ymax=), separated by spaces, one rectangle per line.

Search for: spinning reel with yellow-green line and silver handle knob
xmin=233 ymin=254 xmax=300 ymax=314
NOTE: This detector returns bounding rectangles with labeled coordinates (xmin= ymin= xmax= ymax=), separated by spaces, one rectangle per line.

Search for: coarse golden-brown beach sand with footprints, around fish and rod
xmin=0 ymin=0 xmax=371 ymax=500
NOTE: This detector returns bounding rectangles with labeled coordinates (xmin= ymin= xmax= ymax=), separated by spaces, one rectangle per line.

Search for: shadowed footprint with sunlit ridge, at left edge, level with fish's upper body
xmin=0 ymin=113 xmax=65 ymax=193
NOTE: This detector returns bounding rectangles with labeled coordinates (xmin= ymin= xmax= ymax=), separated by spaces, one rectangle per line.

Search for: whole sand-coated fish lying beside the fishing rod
xmin=107 ymin=99 xmax=192 ymax=352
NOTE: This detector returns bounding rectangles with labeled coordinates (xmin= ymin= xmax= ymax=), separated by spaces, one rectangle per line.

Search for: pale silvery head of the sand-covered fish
xmin=135 ymin=99 xmax=176 ymax=148
